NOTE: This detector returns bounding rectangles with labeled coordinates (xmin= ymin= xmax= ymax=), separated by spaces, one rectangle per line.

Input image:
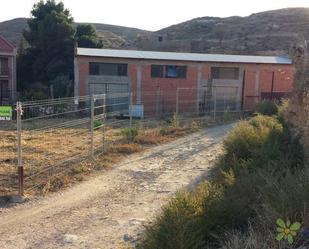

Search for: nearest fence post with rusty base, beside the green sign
xmin=16 ymin=102 xmax=24 ymax=196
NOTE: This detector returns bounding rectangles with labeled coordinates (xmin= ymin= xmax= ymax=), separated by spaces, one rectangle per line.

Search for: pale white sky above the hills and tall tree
xmin=0 ymin=0 xmax=309 ymax=30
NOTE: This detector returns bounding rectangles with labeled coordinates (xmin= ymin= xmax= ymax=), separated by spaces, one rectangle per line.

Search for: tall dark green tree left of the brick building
xmin=23 ymin=0 xmax=75 ymax=96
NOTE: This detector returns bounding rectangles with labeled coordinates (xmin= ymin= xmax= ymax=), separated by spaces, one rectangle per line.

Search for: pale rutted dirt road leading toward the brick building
xmin=0 ymin=125 xmax=232 ymax=249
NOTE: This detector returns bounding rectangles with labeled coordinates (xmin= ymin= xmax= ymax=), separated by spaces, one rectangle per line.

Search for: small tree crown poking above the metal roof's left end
xmin=75 ymin=24 xmax=103 ymax=48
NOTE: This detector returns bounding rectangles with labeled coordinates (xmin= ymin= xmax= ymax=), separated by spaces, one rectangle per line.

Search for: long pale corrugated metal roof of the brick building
xmin=76 ymin=48 xmax=292 ymax=64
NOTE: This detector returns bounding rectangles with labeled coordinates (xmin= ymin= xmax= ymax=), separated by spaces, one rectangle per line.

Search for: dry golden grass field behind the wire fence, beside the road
xmin=0 ymin=115 xmax=226 ymax=196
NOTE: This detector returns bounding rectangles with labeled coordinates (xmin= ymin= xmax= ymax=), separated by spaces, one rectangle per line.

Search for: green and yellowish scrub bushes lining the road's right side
xmin=137 ymin=102 xmax=309 ymax=249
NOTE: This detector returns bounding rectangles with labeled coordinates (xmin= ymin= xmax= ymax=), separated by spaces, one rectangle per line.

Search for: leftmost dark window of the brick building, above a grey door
xmin=89 ymin=62 xmax=128 ymax=76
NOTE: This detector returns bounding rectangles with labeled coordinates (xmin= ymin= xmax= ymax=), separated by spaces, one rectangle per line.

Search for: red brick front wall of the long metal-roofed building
xmin=77 ymin=56 xmax=294 ymax=113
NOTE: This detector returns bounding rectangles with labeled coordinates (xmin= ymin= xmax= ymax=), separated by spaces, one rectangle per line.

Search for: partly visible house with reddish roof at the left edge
xmin=0 ymin=36 xmax=16 ymax=105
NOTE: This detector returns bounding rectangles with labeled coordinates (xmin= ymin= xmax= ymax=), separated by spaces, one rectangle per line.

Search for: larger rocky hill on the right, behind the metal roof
xmin=138 ymin=8 xmax=309 ymax=54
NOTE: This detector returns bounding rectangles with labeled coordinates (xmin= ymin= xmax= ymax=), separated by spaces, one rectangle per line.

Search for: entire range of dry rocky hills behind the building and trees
xmin=0 ymin=8 xmax=309 ymax=54
